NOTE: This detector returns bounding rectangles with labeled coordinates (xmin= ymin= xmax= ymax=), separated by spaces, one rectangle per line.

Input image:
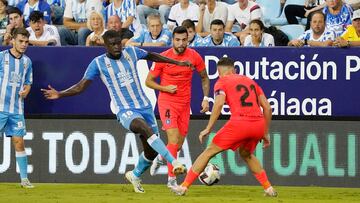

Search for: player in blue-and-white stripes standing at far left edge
xmin=0 ymin=28 xmax=34 ymax=188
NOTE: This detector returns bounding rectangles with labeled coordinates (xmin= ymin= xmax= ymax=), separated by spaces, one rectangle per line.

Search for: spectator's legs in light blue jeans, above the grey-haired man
xmin=137 ymin=0 xmax=175 ymax=25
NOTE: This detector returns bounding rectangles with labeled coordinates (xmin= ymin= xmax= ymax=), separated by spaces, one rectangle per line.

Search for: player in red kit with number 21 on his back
xmin=171 ymin=57 xmax=277 ymax=197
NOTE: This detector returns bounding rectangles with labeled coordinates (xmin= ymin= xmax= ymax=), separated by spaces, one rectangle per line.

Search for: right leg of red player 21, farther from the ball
xmin=239 ymin=148 xmax=278 ymax=197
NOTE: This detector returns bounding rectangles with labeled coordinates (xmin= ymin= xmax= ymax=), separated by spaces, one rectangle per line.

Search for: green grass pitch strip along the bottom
xmin=0 ymin=183 xmax=360 ymax=203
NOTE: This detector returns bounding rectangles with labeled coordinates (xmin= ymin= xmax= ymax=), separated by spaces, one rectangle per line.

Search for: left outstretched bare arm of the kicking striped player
xmin=41 ymin=79 xmax=91 ymax=99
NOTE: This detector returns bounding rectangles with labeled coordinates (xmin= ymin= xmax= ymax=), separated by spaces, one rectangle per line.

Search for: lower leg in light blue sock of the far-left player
xmin=12 ymin=136 xmax=34 ymax=188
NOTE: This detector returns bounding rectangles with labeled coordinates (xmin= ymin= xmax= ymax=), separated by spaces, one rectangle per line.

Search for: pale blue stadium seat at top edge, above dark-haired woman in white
xmin=256 ymin=0 xmax=281 ymax=24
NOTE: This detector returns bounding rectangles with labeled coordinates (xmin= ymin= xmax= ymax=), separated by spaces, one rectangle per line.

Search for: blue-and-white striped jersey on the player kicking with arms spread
xmin=84 ymin=46 xmax=151 ymax=110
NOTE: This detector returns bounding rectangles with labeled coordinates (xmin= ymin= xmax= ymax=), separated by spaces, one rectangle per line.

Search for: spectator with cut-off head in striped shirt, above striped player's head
xmin=104 ymin=0 xmax=142 ymax=34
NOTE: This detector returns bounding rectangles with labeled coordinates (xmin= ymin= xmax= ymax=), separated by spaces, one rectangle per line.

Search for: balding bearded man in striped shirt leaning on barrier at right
xmin=288 ymin=11 xmax=335 ymax=47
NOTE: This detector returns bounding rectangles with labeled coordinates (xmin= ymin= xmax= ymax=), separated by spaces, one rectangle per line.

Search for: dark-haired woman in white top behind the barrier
xmin=244 ymin=19 xmax=275 ymax=47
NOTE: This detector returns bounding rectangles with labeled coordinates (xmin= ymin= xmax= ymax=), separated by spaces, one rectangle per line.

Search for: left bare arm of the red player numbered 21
xmin=199 ymin=94 xmax=225 ymax=143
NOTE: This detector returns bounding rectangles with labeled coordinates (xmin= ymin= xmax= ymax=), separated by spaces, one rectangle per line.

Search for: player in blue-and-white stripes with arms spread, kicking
xmin=42 ymin=30 xmax=192 ymax=193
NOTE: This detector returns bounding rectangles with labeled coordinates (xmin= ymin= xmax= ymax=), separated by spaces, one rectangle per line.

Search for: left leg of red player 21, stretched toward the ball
xmin=171 ymin=143 xmax=223 ymax=196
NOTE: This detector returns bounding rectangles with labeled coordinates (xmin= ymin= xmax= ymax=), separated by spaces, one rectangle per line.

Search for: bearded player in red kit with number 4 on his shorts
xmin=146 ymin=26 xmax=210 ymax=187
